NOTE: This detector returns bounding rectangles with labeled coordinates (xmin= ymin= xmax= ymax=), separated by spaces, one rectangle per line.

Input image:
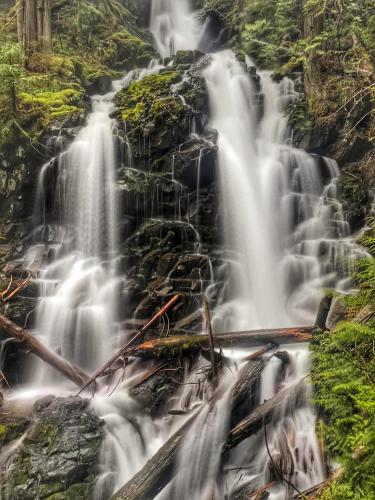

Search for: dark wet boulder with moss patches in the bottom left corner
xmin=0 ymin=396 xmax=103 ymax=500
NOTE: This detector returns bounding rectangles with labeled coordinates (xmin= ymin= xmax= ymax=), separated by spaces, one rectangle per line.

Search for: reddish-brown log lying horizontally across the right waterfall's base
xmin=127 ymin=326 xmax=314 ymax=357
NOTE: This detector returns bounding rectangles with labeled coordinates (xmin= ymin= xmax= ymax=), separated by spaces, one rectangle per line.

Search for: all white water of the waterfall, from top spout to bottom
xmin=2 ymin=0 xmax=368 ymax=500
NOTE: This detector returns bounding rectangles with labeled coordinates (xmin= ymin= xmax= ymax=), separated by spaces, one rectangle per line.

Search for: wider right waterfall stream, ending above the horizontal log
xmin=205 ymin=51 xmax=364 ymax=331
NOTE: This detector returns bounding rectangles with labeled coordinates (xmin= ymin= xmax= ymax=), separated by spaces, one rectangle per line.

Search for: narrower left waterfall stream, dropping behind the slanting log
xmin=30 ymin=93 xmax=119 ymax=381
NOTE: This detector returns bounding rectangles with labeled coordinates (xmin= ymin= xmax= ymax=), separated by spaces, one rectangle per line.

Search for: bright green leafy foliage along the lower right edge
xmin=312 ymin=222 xmax=375 ymax=500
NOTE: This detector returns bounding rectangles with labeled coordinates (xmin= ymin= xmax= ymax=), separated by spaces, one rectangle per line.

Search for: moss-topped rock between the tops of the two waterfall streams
xmin=116 ymin=60 xmax=209 ymax=165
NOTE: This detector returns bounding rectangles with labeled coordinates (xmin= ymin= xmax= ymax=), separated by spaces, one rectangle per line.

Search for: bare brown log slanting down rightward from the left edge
xmin=0 ymin=314 xmax=90 ymax=387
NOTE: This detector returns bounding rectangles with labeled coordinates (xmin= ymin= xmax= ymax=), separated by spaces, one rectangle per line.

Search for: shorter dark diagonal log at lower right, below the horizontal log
xmin=225 ymin=380 xmax=305 ymax=450
